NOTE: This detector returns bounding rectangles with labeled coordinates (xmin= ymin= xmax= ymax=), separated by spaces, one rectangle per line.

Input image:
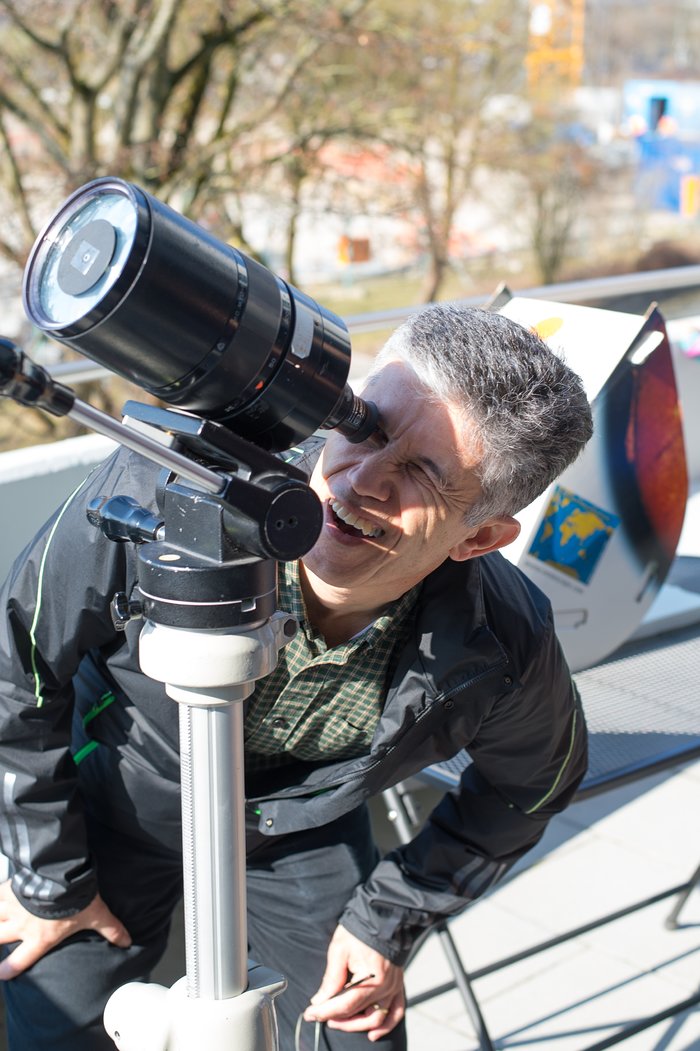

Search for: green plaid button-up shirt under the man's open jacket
xmin=245 ymin=562 xmax=420 ymax=770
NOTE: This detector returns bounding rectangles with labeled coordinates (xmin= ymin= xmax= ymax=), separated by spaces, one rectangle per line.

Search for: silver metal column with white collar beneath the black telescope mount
xmin=140 ymin=612 xmax=296 ymax=1001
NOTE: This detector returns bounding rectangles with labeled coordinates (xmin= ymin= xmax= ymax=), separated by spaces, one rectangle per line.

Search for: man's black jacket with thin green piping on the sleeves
xmin=0 ymin=450 xmax=586 ymax=963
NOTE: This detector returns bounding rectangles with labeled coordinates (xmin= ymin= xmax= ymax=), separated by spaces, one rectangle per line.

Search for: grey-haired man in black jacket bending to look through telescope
xmin=0 ymin=306 xmax=591 ymax=1051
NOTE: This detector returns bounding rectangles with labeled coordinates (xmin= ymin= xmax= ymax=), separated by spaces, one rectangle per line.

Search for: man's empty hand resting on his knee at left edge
xmin=0 ymin=880 xmax=131 ymax=982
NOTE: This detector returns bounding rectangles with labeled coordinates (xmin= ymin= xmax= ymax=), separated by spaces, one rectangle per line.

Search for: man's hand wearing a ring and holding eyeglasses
xmin=304 ymin=927 xmax=406 ymax=1040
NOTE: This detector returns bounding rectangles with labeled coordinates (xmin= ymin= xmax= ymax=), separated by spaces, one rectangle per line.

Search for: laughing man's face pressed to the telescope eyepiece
xmin=303 ymin=362 xmax=493 ymax=601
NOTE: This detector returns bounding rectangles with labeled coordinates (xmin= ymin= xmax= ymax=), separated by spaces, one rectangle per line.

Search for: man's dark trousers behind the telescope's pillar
xmin=4 ymin=808 xmax=406 ymax=1051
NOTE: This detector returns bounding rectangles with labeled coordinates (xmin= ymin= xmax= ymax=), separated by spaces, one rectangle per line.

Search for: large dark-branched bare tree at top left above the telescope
xmin=0 ymin=0 xmax=374 ymax=266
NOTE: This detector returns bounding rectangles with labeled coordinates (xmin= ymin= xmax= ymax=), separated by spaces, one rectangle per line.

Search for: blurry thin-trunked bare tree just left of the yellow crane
xmin=334 ymin=0 xmax=527 ymax=300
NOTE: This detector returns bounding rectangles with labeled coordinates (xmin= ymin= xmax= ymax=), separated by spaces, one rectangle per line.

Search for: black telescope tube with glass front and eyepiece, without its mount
xmin=23 ymin=178 xmax=376 ymax=452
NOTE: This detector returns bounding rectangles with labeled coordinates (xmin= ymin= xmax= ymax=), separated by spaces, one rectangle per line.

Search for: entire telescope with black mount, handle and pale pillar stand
xmin=0 ymin=178 xmax=384 ymax=1051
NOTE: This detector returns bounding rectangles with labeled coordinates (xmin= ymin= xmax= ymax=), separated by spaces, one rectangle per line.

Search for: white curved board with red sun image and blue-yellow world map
xmin=496 ymin=296 xmax=687 ymax=671
